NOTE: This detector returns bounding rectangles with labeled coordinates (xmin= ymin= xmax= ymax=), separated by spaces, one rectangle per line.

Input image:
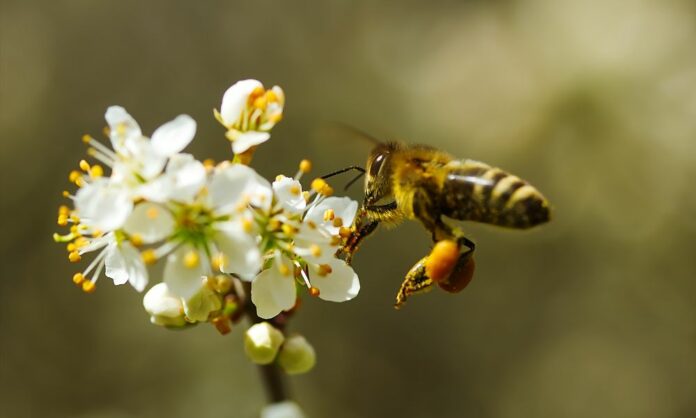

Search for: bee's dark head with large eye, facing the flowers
xmin=365 ymin=142 xmax=398 ymax=205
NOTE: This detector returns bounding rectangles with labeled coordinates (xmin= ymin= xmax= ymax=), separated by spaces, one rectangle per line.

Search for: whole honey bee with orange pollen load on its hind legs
xmin=332 ymin=142 xmax=550 ymax=309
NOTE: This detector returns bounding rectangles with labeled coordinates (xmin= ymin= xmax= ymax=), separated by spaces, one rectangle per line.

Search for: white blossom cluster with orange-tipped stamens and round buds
xmin=54 ymin=80 xmax=360 ymax=373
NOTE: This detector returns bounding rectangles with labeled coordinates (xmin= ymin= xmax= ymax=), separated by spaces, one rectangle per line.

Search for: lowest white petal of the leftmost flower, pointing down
xmin=104 ymin=242 xmax=148 ymax=292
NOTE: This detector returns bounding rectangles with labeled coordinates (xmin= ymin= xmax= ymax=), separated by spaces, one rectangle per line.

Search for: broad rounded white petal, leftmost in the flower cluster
xmin=75 ymin=178 xmax=133 ymax=232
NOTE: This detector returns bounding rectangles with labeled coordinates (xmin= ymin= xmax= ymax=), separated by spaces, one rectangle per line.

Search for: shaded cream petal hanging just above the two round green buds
xmin=251 ymin=258 xmax=297 ymax=319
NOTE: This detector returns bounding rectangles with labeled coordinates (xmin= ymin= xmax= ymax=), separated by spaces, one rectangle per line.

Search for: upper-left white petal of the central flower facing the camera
xmin=165 ymin=154 xmax=206 ymax=202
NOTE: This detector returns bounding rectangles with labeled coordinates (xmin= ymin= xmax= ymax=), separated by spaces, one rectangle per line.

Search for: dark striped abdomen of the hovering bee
xmin=440 ymin=160 xmax=550 ymax=228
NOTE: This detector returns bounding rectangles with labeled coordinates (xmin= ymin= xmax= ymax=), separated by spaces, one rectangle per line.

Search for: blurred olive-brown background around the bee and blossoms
xmin=0 ymin=0 xmax=696 ymax=418
